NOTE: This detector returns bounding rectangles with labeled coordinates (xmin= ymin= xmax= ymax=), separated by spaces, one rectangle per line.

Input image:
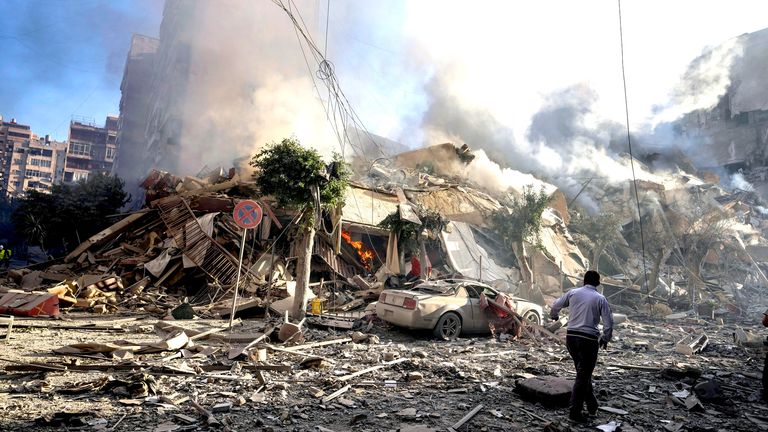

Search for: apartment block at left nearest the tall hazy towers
xmin=64 ymin=116 xmax=118 ymax=183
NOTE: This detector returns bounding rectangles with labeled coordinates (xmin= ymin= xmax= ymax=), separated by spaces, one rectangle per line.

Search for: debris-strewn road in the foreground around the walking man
xmin=0 ymin=314 xmax=768 ymax=431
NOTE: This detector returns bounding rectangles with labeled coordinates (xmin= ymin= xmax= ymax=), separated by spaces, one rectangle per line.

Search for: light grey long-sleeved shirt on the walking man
xmin=550 ymin=285 xmax=613 ymax=342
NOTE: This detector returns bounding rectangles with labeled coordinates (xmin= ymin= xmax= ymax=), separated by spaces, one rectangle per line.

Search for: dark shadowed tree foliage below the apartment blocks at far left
xmin=11 ymin=174 xmax=128 ymax=253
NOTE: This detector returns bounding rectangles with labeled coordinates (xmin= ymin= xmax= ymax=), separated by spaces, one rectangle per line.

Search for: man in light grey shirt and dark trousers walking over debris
xmin=549 ymin=270 xmax=613 ymax=423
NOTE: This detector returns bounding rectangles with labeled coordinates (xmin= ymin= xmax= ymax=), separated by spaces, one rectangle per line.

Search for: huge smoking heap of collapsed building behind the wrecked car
xmin=0 ymin=138 xmax=768 ymax=327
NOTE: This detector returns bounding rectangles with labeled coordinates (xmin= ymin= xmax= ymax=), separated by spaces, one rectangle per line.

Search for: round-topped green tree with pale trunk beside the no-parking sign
xmin=250 ymin=138 xmax=351 ymax=318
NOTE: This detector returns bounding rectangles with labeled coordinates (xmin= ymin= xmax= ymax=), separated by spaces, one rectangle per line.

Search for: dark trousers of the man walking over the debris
xmin=565 ymin=330 xmax=598 ymax=414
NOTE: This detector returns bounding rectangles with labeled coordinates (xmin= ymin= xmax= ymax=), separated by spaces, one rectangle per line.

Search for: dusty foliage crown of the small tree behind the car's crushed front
xmin=491 ymin=185 xmax=549 ymax=246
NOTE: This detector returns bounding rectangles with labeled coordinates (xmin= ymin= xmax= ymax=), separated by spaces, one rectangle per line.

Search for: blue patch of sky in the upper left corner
xmin=0 ymin=0 xmax=162 ymax=140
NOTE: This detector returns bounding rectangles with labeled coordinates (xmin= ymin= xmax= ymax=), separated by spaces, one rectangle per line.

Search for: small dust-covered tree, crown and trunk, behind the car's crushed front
xmin=491 ymin=185 xmax=549 ymax=300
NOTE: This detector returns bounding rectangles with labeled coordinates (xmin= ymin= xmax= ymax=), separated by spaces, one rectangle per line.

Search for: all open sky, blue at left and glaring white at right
xmin=0 ymin=0 xmax=768 ymax=145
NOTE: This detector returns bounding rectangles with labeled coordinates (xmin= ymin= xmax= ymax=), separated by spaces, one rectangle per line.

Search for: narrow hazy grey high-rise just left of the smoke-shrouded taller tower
xmin=112 ymin=34 xmax=160 ymax=196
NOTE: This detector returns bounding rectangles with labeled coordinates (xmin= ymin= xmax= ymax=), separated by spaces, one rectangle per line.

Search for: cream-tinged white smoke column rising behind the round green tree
xmin=161 ymin=0 xmax=404 ymax=174
